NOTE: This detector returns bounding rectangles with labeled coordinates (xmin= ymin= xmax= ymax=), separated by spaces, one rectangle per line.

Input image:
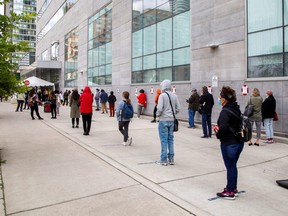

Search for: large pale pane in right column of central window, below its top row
xmin=173 ymin=12 xmax=190 ymax=49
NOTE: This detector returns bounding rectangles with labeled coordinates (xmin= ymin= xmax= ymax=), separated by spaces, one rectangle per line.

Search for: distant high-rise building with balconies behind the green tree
xmin=5 ymin=0 xmax=36 ymax=71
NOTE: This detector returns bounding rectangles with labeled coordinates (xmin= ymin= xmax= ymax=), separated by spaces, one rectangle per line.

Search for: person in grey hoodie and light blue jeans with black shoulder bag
xmin=157 ymin=80 xmax=180 ymax=166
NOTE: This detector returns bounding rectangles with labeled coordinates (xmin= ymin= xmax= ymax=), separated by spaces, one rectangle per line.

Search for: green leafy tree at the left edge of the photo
xmin=0 ymin=0 xmax=35 ymax=96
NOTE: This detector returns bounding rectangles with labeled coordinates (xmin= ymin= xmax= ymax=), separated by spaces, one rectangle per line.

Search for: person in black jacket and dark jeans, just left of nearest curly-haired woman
xmin=199 ymin=86 xmax=214 ymax=138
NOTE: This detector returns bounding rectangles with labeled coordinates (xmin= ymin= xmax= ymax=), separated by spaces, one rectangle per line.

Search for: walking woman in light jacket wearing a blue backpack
xmin=116 ymin=91 xmax=134 ymax=146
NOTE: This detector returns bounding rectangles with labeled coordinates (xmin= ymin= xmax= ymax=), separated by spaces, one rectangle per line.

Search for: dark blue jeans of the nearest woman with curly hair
xmin=221 ymin=143 xmax=244 ymax=192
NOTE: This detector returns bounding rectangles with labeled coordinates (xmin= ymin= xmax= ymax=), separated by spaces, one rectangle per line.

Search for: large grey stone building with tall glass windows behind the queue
xmin=28 ymin=0 xmax=288 ymax=133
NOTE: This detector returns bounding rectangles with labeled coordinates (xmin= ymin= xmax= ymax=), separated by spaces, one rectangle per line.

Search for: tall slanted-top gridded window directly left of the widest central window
xmin=88 ymin=3 xmax=112 ymax=86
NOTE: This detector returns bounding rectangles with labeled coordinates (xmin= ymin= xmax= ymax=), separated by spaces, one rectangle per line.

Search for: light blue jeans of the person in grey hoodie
xmin=158 ymin=121 xmax=174 ymax=162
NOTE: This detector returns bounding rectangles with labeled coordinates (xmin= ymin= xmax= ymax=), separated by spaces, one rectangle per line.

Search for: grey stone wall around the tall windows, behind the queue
xmin=36 ymin=0 xmax=288 ymax=134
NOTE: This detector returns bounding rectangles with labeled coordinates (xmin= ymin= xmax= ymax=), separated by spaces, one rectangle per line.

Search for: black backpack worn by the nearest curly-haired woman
xmin=223 ymin=109 xmax=252 ymax=142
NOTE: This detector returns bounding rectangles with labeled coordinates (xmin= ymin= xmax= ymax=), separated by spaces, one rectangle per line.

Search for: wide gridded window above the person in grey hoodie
xmin=132 ymin=0 xmax=191 ymax=83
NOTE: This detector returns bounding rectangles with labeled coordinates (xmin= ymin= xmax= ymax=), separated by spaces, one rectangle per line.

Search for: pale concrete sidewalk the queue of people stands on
xmin=0 ymin=103 xmax=288 ymax=216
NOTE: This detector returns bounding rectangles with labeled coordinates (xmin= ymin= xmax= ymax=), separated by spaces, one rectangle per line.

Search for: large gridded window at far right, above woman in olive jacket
xmin=247 ymin=0 xmax=288 ymax=78
